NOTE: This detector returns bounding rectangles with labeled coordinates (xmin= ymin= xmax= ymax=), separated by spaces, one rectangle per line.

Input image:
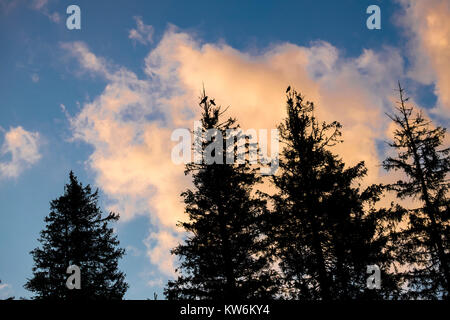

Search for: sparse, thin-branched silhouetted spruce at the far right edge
xmin=383 ymin=83 xmax=450 ymax=299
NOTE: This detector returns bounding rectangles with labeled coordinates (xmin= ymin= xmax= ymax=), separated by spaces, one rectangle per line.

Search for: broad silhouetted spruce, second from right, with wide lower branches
xmin=267 ymin=87 xmax=396 ymax=300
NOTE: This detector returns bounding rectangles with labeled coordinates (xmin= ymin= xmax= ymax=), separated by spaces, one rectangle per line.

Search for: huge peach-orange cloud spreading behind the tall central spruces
xmin=62 ymin=27 xmax=414 ymax=276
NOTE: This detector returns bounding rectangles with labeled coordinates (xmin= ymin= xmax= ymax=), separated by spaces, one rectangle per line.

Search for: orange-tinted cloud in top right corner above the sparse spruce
xmin=398 ymin=0 xmax=450 ymax=119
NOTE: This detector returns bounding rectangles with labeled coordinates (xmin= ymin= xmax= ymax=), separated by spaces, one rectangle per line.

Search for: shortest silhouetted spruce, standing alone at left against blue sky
xmin=25 ymin=172 xmax=128 ymax=300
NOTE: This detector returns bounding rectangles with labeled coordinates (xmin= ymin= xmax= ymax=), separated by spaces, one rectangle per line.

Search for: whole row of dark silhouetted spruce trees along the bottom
xmin=2 ymin=83 xmax=450 ymax=301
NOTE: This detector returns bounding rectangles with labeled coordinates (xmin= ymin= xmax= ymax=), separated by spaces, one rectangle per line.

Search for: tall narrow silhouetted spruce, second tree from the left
xmin=165 ymin=92 xmax=277 ymax=300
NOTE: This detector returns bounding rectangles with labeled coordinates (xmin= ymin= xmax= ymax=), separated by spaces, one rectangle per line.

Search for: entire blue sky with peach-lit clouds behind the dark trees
xmin=0 ymin=0 xmax=450 ymax=299
